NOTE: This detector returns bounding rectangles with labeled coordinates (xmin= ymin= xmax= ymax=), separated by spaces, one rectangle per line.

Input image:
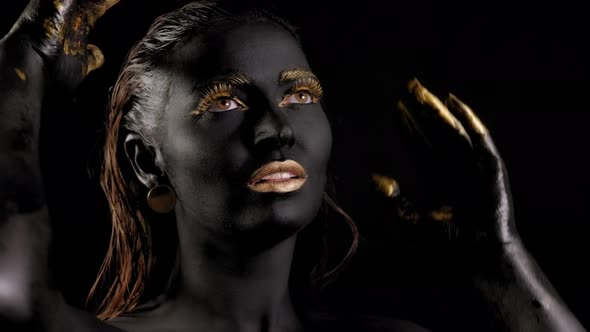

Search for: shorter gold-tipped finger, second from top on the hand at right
xmin=445 ymin=94 xmax=498 ymax=157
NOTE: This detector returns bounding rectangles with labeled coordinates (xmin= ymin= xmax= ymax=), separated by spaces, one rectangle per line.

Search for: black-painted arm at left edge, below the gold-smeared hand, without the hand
xmin=0 ymin=23 xmax=49 ymax=326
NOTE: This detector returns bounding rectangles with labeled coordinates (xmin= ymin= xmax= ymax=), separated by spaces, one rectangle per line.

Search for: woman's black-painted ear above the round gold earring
xmin=125 ymin=132 xmax=164 ymax=188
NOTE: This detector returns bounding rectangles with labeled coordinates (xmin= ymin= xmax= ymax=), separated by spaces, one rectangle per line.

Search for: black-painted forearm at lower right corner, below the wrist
xmin=475 ymin=239 xmax=585 ymax=332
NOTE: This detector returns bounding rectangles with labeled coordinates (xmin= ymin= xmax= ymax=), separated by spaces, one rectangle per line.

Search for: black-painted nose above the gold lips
xmin=254 ymin=109 xmax=295 ymax=150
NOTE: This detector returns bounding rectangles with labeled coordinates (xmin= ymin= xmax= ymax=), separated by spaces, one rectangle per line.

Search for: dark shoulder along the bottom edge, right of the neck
xmin=312 ymin=314 xmax=429 ymax=332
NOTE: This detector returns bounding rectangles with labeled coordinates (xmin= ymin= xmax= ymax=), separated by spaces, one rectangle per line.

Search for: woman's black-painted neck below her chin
xmin=166 ymin=214 xmax=306 ymax=331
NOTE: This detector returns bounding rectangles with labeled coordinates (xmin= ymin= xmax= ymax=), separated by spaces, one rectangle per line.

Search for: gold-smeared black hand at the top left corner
xmin=11 ymin=0 xmax=119 ymax=90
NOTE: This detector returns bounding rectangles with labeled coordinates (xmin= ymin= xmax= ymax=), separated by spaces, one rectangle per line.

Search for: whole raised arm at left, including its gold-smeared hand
xmin=0 ymin=0 xmax=115 ymax=328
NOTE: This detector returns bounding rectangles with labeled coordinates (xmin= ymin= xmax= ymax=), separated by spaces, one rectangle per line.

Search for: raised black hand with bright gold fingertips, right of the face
xmin=375 ymin=80 xmax=519 ymax=268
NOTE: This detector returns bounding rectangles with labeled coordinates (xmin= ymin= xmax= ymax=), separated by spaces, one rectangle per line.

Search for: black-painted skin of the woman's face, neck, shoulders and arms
xmin=0 ymin=0 xmax=584 ymax=332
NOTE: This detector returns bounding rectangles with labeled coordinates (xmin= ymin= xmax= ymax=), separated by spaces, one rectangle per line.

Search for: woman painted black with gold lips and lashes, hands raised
xmin=0 ymin=0 xmax=583 ymax=331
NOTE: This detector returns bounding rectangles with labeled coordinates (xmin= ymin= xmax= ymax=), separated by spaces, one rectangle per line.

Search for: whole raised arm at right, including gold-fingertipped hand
xmin=386 ymin=80 xmax=585 ymax=332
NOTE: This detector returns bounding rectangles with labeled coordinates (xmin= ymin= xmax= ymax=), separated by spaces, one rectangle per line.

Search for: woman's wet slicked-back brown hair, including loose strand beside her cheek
xmin=88 ymin=1 xmax=358 ymax=319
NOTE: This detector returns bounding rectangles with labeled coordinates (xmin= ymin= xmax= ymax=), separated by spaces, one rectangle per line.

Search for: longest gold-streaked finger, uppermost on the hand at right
xmin=404 ymin=79 xmax=471 ymax=145
